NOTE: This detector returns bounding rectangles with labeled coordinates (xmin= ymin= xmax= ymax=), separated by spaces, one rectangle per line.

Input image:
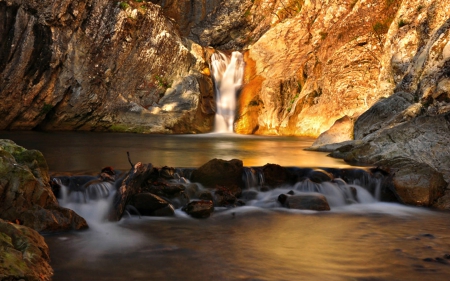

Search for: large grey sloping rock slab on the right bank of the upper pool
xmin=345 ymin=112 xmax=450 ymax=206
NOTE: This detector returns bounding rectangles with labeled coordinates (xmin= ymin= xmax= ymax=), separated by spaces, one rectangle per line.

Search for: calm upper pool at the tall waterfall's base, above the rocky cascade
xmin=0 ymin=132 xmax=348 ymax=172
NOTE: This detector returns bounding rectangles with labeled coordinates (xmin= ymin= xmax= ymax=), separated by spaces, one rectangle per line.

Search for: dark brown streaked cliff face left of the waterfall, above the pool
xmin=0 ymin=0 xmax=214 ymax=133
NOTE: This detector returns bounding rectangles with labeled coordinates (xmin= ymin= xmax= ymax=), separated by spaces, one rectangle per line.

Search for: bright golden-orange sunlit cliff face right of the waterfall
xmin=236 ymin=0 xmax=450 ymax=137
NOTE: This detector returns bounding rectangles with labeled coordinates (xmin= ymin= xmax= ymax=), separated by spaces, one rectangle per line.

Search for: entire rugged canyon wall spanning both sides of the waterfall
xmin=0 ymin=0 xmax=449 ymax=139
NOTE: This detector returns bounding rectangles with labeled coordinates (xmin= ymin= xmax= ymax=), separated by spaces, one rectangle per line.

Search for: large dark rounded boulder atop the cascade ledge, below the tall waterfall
xmin=190 ymin=159 xmax=245 ymax=188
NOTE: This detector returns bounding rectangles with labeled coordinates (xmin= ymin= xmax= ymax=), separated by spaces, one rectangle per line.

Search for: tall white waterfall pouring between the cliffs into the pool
xmin=211 ymin=51 xmax=244 ymax=133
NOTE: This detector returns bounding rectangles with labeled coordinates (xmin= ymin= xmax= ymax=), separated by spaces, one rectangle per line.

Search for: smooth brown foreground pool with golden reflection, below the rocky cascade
xmin=46 ymin=210 xmax=450 ymax=281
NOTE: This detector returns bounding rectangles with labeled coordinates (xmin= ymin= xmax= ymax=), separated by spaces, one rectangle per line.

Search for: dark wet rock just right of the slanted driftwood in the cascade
xmin=130 ymin=193 xmax=175 ymax=216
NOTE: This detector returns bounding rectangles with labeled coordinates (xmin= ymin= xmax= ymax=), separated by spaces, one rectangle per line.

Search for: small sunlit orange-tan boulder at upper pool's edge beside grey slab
xmin=312 ymin=115 xmax=354 ymax=148
